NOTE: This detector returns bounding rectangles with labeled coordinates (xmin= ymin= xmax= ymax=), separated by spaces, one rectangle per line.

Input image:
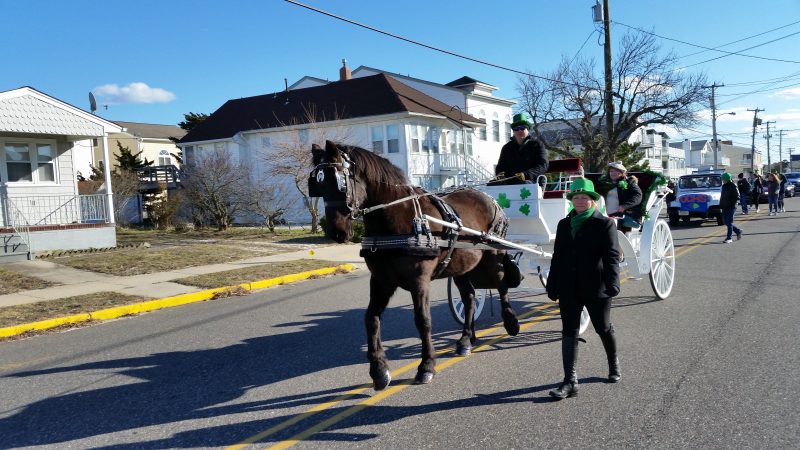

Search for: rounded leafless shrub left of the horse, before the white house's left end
xmin=183 ymin=149 xmax=248 ymax=231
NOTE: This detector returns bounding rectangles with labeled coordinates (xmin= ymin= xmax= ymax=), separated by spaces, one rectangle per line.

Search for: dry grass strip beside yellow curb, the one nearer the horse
xmin=173 ymin=259 xmax=341 ymax=289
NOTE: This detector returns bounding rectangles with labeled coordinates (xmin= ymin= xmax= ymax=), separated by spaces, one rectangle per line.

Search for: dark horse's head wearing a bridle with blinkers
xmin=308 ymin=141 xmax=364 ymax=243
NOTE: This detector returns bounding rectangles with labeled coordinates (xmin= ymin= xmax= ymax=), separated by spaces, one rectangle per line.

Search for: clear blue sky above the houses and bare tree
xmin=0 ymin=0 xmax=800 ymax=158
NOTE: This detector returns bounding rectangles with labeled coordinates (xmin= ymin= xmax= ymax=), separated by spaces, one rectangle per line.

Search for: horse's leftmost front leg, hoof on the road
xmin=364 ymin=275 xmax=397 ymax=391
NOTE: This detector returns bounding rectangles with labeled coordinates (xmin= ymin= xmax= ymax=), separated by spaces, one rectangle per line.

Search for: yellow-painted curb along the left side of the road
xmin=0 ymin=264 xmax=353 ymax=339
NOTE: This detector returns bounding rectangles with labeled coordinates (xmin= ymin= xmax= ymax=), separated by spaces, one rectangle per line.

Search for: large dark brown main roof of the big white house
xmin=180 ymin=74 xmax=484 ymax=143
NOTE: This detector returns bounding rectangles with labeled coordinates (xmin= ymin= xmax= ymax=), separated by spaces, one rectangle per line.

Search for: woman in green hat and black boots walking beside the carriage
xmin=547 ymin=178 xmax=620 ymax=399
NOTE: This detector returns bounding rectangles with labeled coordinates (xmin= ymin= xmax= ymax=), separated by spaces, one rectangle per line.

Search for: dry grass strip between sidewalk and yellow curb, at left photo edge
xmin=0 ymin=292 xmax=145 ymax=328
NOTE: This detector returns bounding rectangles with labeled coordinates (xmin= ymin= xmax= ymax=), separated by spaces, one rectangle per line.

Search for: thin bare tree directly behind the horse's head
xmin=261 ymin=104 xmax=360 ymax=233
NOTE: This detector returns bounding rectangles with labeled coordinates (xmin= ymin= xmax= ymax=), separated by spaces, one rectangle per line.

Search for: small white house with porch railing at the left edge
xmin=0 ymin=87 xmax=122 ymax=261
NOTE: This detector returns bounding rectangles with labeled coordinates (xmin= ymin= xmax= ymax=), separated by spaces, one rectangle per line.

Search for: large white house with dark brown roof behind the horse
xmin=178 ymin=66 xmax=513 ymax=220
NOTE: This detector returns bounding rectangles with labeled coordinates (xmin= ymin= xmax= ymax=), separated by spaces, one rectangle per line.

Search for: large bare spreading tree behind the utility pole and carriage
xmin=518 ymin=33 xmax=708 ymax=171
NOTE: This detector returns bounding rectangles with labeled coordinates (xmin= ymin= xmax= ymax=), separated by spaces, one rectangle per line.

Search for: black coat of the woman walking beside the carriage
xmin=547 ymin=210 xmax=620 ymax=304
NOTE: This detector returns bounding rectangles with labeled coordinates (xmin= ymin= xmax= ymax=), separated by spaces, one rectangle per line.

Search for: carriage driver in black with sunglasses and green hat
xmin=491 ymin=113 xmax=548 ymax=184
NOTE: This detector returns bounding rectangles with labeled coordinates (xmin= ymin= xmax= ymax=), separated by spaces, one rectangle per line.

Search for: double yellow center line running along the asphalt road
xmin=227 ymin=216 xmax=753 ymax=449
